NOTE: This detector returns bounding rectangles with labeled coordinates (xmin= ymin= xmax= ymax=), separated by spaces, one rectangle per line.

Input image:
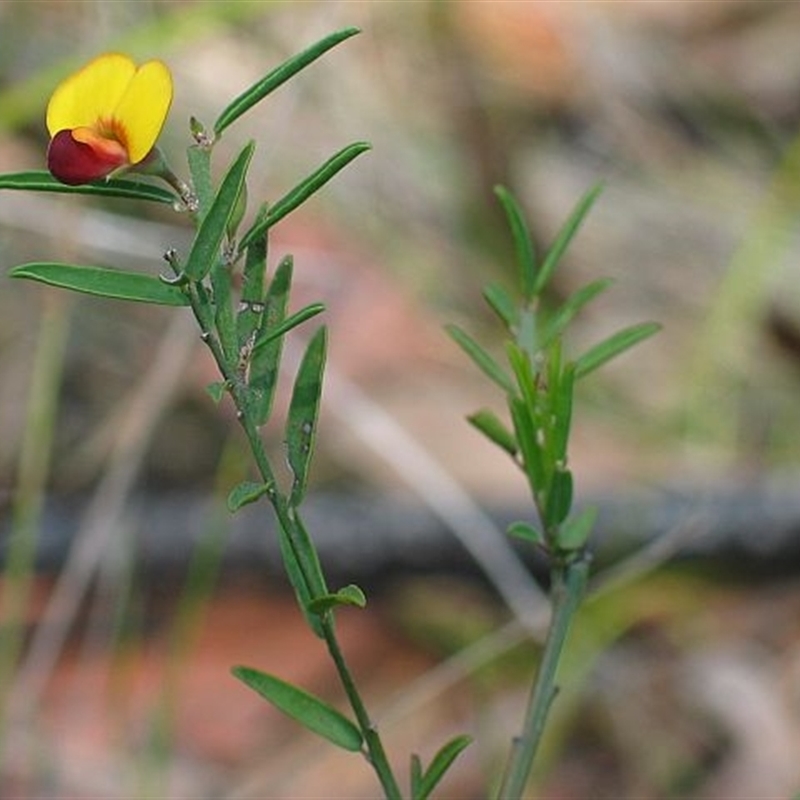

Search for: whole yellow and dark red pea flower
xmin=47 ymin=53 xmax=172 ymax=185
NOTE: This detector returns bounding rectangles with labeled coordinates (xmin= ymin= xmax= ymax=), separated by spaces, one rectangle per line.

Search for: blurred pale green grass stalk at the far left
xmin=0 ymin=291 xmax=72 ymax=749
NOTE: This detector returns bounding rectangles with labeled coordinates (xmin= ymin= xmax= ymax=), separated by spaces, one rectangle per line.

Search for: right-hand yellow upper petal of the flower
xmin=113 ymin=61 xmax=172 ymax=164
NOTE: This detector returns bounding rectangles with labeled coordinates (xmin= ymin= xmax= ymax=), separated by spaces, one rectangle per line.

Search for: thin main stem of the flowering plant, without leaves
xmin=189 ymin=291 xmax=402 ymax=800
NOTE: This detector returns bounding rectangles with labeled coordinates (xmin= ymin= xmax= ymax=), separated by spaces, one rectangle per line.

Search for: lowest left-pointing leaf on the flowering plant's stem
xmin=232 ymin=667 xmax=363 ymax=752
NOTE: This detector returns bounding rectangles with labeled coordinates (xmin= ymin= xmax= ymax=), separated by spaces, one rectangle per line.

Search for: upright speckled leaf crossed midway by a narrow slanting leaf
xmin=248 ymin=256 xmax=292 ymax=425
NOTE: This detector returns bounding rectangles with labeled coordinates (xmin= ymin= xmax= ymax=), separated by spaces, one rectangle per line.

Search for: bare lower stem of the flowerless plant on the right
xmin=498 ymin=555 xmax=589 ymax=800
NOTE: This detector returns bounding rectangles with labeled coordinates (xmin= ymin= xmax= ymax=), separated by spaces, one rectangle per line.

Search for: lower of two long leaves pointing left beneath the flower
xmin=8 ymin=262 xmax=189 ymax=306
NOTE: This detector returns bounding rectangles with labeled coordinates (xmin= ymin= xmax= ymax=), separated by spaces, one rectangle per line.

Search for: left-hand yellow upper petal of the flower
xmin=47 ymin=53 xmax=136 ymax=136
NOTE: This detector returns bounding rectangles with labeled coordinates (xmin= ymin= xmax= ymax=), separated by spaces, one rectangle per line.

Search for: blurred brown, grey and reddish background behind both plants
xmin=0 ymin=0 xmax=800 ymax=800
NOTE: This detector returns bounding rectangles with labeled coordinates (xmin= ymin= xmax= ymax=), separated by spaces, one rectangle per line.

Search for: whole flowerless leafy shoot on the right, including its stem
xmin=448 ymin=186 xmax=660 ymax=800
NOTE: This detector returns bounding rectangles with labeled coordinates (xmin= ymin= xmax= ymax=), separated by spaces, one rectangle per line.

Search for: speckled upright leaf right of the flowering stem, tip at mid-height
xmin=286 ymin=327 xmax=327 ymax=506
